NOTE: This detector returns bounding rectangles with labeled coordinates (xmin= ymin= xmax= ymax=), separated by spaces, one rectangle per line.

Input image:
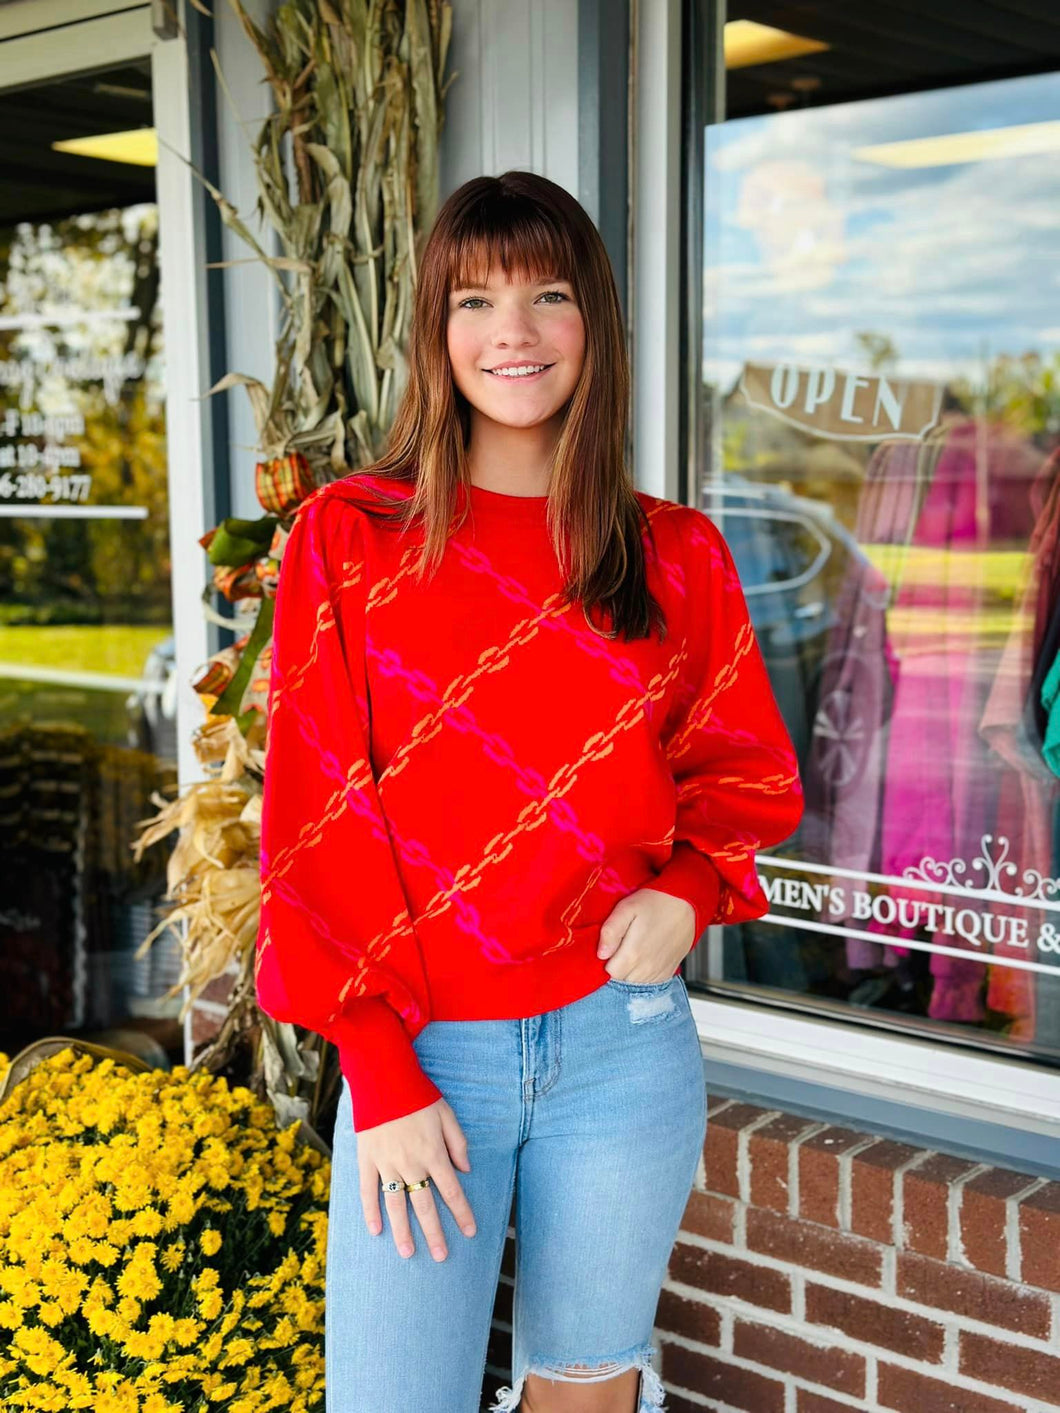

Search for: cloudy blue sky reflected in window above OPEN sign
xmin=704 ymin=73 xmax=1060 ymax=391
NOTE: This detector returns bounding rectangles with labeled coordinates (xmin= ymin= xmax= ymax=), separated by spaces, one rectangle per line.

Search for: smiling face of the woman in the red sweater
xmin=447 ymin=270 xmax=585 ymax=427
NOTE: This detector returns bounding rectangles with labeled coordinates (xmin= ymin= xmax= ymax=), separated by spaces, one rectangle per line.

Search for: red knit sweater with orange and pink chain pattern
xmin=257 ymin=473 xmax=803 ymax=1132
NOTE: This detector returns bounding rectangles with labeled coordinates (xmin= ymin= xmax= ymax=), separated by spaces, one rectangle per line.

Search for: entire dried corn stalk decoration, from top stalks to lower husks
xmin=133 ymin=0 xmax=455 ymax=1123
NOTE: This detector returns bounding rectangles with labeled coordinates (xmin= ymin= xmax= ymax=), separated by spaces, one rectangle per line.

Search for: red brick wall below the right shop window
xmin=656 ymin=1096 xmax=1060 ymax=1413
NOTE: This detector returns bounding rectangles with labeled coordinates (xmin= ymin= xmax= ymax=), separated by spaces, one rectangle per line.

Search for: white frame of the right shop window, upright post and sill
xmin=630 ymin=0 xmax=1060 ymax=1139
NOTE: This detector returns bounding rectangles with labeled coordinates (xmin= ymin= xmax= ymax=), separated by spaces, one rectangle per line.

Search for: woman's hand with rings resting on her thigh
xmin=358 ymin=1099 xmax=475 ymax=1260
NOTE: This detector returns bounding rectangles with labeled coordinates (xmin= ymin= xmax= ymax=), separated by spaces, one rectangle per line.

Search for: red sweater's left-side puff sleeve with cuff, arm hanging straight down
xmin=256 ymin=487 xmax=441 ymax=1132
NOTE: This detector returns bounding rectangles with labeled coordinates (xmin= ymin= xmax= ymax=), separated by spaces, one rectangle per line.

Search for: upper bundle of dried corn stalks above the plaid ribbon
xmin=211 ymin=0 xmax=455 ymax=485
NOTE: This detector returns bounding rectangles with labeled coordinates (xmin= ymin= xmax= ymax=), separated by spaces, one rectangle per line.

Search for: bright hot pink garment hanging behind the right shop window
xmin=868 ymin=420 xmax=1040 ymax=1023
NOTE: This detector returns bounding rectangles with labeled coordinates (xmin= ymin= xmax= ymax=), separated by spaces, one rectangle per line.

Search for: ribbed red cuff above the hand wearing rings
xmin=329 ymin=996 xmax=442 ymax=1133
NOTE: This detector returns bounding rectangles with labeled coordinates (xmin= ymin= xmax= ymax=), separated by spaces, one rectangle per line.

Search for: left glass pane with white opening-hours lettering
xmin=0 ymin=57 xmax=181 ymax=1058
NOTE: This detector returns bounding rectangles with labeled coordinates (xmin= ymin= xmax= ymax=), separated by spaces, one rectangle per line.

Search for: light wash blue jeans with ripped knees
xmin=325 ymin=975 xmax=707 ymax=1413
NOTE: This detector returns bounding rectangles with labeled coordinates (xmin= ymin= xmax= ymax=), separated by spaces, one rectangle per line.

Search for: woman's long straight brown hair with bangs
xmin=343 ymin=171 xmax=667 ymax=640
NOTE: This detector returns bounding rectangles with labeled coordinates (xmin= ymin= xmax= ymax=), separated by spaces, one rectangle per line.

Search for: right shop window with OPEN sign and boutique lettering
xmin=688 ymin=0 xmax=1060 ymax=1063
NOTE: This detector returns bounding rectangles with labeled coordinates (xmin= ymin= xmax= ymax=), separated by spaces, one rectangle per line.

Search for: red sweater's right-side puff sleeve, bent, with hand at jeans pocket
xmin=647 ymin=507 xmax=803 ymax=942
